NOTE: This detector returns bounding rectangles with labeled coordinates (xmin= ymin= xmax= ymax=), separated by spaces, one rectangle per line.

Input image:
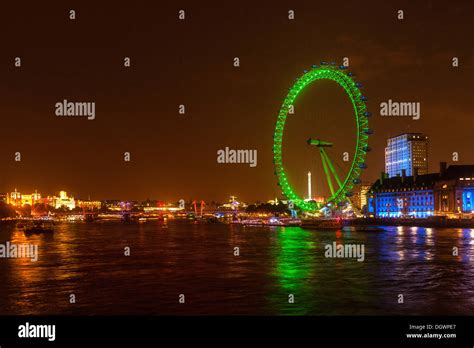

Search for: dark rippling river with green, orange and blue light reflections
xmin=0 ymin=221 xmax=474 ymax=315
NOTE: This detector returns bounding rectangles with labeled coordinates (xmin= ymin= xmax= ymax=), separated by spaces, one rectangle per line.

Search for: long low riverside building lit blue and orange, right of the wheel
xmin=368 ymin=162 xmax=474 ymax=218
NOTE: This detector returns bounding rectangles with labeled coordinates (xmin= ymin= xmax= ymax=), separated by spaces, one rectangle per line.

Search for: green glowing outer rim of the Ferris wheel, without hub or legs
xmin=273 ymin=63 xmax=371 ymax=212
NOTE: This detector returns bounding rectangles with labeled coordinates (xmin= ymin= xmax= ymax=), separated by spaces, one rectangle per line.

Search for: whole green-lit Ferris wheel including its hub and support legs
xmin=273 ymin=62 xmax=372 ymax=213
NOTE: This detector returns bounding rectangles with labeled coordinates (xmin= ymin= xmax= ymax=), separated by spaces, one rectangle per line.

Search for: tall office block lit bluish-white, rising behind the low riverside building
xmin=385 ymin=133 xmax=428 ymax=177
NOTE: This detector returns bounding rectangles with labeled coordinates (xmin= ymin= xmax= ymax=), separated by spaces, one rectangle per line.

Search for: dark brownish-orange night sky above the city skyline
xmin=0 ymin=1 xmax=474 ymax=201
